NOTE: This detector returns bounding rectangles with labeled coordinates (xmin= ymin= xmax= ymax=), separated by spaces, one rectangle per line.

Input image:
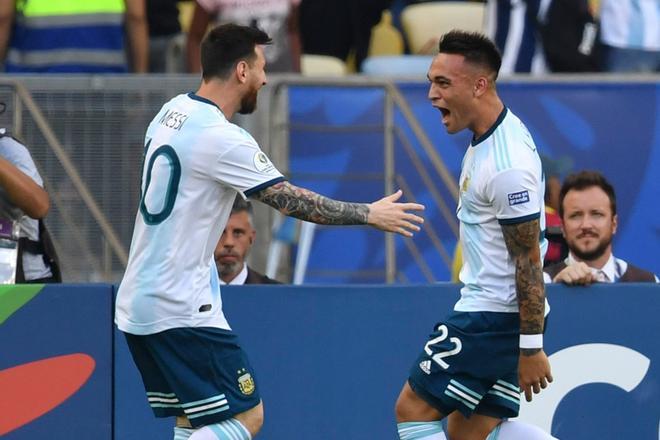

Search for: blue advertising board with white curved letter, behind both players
xmin=115 ymin=284 xmax=660 ymax=440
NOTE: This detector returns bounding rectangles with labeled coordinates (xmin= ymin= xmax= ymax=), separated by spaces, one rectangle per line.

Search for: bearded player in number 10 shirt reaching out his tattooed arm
xmin=115 ymin=24 xmax=424 ymax=440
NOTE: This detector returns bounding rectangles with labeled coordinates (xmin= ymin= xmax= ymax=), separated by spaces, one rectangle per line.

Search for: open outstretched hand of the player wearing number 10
xmin=367 ymin=190 xmax=424 ymax=237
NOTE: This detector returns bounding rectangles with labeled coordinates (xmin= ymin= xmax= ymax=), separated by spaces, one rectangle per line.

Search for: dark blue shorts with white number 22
xmin=408 ymin=312 xmax=520 ymax=418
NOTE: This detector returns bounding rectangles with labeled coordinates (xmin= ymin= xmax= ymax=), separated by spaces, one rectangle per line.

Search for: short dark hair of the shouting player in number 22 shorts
xmin=438 ymin=29 xmax=502 ymax=79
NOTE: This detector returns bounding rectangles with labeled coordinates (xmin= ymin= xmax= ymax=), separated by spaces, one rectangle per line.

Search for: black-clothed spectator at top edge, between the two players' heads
xmin=300 ymin=0 xmax=392 ymax=71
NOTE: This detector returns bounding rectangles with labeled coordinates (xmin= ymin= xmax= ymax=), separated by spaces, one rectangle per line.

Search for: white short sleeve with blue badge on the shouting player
xmin=488 ymin=168 xmax=543 ymax=224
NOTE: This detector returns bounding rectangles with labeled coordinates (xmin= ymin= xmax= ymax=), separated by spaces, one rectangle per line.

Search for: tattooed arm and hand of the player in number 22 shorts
xmin=502 ymin=220 xmax=552 ymax=402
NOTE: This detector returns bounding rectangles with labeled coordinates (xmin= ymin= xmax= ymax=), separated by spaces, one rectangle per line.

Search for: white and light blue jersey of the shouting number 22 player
xmin=454 ymin=108 xmax=547 ymax=312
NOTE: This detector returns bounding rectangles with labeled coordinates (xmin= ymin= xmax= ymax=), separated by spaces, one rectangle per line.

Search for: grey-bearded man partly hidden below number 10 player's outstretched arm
xmin=213 ymin=196 xmax=280 ymax=285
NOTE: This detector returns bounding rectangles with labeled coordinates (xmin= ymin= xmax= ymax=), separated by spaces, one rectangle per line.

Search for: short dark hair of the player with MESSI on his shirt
xmin=201 ymin=23 xmax=272 ymax=80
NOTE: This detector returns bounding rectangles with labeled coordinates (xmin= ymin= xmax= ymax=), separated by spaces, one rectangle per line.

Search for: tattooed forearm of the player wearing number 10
xmin=253 ymin=182 xmax=369 ymax=225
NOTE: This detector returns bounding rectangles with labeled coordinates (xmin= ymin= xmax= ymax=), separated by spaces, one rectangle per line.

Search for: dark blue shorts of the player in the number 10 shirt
xmin=124 ymin=327 xmax=261 ymax=428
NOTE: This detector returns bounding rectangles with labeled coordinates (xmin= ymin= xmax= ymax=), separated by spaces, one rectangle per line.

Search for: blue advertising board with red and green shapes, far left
xmin=0 ymin=285 xmax=113 ymax=440
